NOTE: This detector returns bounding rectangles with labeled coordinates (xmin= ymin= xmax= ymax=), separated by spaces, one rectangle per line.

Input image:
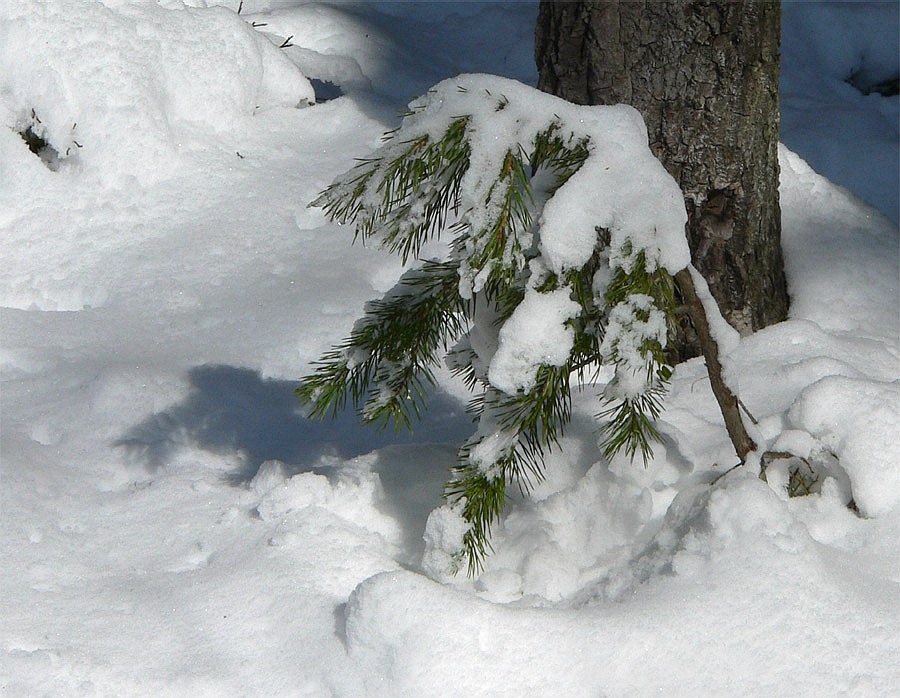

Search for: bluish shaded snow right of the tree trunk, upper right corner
xmin=781 ymin=2 xmax=900 ymax=225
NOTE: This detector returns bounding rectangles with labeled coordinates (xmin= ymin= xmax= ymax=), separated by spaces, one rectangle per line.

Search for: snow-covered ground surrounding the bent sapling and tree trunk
xmin=0 ymin=0 xmax=900 ymax=698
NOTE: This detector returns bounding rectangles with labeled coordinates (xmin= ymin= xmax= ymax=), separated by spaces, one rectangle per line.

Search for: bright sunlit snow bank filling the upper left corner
xmin=0 ymin=0 xmax=315 ymax=185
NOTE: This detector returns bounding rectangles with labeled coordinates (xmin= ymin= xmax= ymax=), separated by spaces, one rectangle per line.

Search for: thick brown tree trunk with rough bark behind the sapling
xmin=535 ymin=0 xmax=788 ymax=359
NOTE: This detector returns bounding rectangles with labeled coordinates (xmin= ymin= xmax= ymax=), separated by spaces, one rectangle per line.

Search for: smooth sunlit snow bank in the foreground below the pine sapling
xmin=346 ymin=474 xmax=900 ymax=697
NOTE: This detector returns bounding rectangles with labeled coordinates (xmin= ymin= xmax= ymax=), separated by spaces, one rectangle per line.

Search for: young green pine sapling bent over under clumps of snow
xmin=297 ymin=75 xmax=755 ymax=573
